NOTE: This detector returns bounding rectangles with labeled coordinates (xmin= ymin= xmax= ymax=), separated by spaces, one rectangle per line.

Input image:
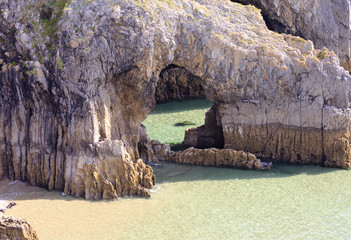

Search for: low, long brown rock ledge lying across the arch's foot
xmin=167 ymin=147 xmax=271 ymax=170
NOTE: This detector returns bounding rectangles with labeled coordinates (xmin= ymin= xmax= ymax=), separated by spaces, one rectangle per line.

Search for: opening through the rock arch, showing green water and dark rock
xmin=143 ymin=64 xmax=224 ymax=151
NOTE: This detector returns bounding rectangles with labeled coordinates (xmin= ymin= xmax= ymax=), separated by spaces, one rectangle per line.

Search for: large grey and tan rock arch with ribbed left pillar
xmin=0 ymin=0 xmax=351 ymax=201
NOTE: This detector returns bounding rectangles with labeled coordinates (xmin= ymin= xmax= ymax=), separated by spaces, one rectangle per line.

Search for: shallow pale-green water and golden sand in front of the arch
xmin=0 ymin=98 xmax=351 ymax=240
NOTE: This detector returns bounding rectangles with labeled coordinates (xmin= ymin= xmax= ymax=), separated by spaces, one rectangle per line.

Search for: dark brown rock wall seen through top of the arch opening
xmin=155 ymin=65 xmax=205 ymax=102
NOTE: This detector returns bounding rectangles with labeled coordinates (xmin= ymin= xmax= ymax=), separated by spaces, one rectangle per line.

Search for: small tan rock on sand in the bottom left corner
xmin=0 ymin=216 xmax=39 ymax=240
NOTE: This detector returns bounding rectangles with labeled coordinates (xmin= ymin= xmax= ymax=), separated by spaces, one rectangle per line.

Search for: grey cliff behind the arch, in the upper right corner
xmin=234 ymin=0 xmax=351 ymax=71
